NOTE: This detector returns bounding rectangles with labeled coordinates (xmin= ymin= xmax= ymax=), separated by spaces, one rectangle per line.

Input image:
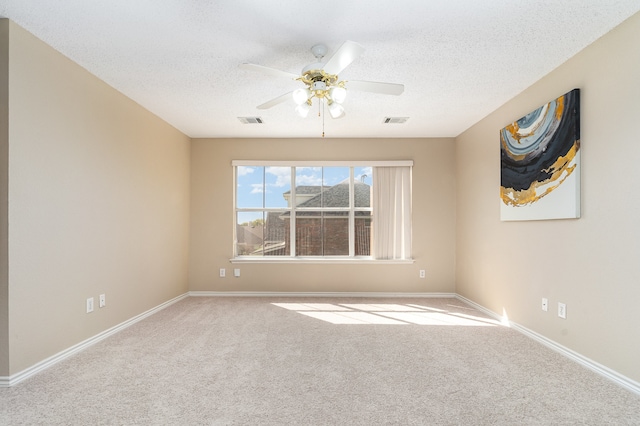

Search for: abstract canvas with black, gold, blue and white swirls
xmin=500 ymin=89 xmax=580 ymax=221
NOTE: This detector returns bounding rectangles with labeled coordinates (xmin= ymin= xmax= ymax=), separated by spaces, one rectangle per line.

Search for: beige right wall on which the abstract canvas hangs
xmin=456 ymin=14 xmax=640 ymax=381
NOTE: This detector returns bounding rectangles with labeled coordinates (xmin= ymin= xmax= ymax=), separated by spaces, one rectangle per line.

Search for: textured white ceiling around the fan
xmin=0 ymin=0 xmax=640 ymax=137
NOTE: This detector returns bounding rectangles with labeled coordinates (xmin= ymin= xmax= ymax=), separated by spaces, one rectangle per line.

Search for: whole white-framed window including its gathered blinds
xmin=233 ymin=161 xmax=411 ymax=261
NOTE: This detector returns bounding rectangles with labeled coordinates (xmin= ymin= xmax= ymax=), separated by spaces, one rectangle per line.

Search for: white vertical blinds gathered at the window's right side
xmin=373 ymin=167 xmax=411 ymax=259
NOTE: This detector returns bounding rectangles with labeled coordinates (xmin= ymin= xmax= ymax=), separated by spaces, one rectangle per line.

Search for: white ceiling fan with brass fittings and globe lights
xmin=240 ymin=40 xmax=404 ymax=118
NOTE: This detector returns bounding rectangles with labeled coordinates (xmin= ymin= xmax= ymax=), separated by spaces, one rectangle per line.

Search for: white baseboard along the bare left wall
xmin=0 ymin=293 xmax=189 ymax=388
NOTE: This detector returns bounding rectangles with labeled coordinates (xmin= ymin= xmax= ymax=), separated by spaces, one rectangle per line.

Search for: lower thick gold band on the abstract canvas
xmin=500 ymin=140 xmax=580 ymax=207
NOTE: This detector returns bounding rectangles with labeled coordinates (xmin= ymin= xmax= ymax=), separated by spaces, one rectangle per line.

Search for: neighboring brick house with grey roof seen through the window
xmin=246 ymin=181 xmax=371 ymax=256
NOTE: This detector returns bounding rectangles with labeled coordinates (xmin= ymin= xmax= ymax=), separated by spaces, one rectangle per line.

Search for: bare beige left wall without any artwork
xmin=0 ymin=21 xmax=190 ymax=375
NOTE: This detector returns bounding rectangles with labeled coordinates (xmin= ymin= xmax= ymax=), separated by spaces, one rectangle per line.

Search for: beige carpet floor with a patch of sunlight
xmin=0 ymin=297 xmax=640 ymax=425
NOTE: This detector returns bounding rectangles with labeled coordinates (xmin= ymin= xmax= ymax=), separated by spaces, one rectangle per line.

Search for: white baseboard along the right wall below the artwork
xmin=456 ymin=294 xmax=640 ymax=395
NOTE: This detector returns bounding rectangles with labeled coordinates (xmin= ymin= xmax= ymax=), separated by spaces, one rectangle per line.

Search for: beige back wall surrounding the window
xmin=189 ymin=139 xmax=455 ymax=292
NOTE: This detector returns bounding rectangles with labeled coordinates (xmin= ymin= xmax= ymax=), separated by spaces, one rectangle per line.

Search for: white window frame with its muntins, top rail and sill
xmin=230 ymin=160 xmax=413 ymax=263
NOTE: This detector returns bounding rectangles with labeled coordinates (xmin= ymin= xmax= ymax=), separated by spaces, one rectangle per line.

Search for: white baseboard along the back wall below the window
xmin=189 ymin=291 xmax=456 ymax=298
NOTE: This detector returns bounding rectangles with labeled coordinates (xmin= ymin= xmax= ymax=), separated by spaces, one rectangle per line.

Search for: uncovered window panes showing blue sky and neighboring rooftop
xmin=235 ymin=166 xmax=372 ymax=257
